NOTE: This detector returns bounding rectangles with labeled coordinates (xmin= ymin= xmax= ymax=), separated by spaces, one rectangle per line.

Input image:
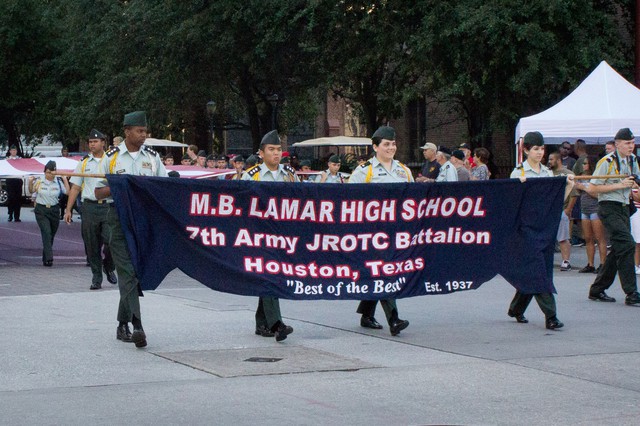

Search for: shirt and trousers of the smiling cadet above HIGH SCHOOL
xmin=348 ymin=157 xmax=413 ymax=325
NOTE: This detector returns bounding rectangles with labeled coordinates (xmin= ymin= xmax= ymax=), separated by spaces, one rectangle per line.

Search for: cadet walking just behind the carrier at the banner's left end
xmin=64 ymin=129 xmax=118 ymax=290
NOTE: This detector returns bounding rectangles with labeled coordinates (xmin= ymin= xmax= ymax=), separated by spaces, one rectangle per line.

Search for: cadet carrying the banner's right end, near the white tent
xmin=507 ymin=132 xmax=573 ymax=330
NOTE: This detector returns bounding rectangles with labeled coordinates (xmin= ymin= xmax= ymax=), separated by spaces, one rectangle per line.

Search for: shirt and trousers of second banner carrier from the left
xmin=242 ymin=164 xmax=298 ymax=331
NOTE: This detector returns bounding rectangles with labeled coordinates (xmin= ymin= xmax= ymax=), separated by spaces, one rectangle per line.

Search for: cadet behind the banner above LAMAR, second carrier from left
xmin=242 ymin=130 xmax=298 ymax=342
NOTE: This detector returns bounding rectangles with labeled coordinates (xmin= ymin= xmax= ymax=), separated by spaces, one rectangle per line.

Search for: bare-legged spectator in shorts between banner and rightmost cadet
xmin=575 ymin=156 xmax=608 ymax=273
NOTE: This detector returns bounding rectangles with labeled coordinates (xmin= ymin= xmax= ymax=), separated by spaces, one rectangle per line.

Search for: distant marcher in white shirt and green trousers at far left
xmin=29 ymin=161 xmax=69 ymax=266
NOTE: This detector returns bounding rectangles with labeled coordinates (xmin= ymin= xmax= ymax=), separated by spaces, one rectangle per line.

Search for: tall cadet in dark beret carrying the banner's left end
xmin=95 ymin=111 xmax=167 ymax=348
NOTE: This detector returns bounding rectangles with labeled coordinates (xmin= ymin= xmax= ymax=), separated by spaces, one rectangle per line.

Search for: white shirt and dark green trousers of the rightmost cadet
xmin=589 ymin=150 xmax=640 ymax=295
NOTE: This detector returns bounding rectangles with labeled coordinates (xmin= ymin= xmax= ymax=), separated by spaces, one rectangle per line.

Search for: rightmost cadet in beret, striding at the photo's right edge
xmin=588 ymin=128 xmax=640 ymax=305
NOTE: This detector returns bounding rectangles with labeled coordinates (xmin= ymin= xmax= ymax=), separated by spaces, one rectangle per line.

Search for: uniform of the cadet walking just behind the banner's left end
xmin=69 ymin=147 xmax=117 ymax=290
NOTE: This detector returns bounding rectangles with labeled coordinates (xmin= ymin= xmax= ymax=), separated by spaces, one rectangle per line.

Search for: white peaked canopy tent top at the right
xmin=515 ymin=61 xmax=640 ymax=144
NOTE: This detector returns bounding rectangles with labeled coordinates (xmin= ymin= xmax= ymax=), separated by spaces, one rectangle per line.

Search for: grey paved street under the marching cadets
xmin=0 ymin=208 xmax=640 ymax=425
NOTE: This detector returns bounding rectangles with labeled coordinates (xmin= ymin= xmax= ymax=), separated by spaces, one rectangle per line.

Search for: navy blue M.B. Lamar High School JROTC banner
xmin=107 ymin=175 xmax=565 ymax=299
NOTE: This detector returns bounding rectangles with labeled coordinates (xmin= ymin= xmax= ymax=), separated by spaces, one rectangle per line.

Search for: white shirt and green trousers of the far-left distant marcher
xmin=34 ymin=177 xmax=63 ymax=266
